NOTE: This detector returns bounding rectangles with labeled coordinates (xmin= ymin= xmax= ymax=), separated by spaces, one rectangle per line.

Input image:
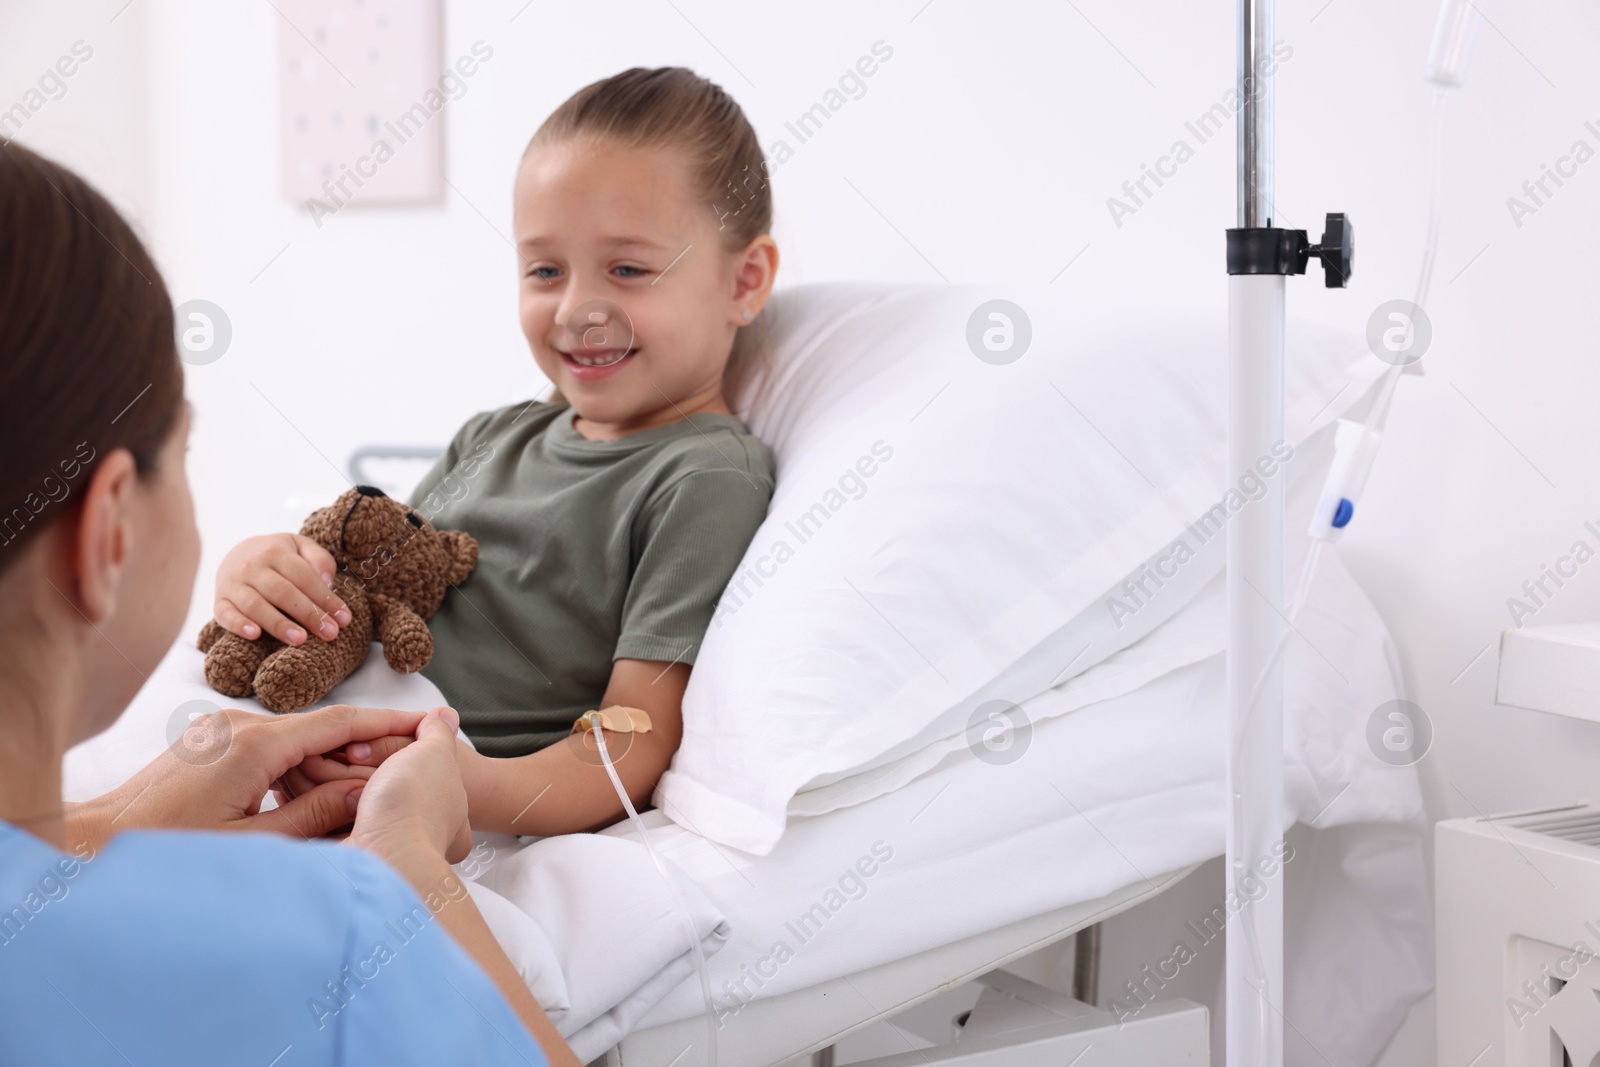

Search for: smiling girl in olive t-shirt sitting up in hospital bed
xmin=214 ymin=67 xmax=778 ymax=835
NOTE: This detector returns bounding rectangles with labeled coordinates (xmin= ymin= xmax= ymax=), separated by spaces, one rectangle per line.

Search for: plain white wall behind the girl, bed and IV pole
xmin=9 ymin=0 xmax=1600 ymax=1055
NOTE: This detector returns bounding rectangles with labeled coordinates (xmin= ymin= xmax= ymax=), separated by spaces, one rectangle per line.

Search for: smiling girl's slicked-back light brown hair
xmin=528 ymin=67 xmax=773 ymax=411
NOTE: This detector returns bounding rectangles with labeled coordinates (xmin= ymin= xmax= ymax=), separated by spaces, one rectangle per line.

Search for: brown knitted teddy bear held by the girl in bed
xmin=200 ymin=485 xmax=478 ymax=712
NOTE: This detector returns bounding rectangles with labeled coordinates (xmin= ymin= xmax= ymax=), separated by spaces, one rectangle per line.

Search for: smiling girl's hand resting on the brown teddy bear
xmin=211 ymin=533 xmax=350 ymax=645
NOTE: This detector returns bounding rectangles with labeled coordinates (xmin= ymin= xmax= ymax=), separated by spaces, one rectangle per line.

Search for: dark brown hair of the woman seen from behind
xmin=0 ymin=141 xmax=184 ymax=571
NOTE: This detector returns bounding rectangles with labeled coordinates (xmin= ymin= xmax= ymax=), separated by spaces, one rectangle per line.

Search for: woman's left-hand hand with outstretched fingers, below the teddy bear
xmin=67 ymin=704 xmax=422 ymax=846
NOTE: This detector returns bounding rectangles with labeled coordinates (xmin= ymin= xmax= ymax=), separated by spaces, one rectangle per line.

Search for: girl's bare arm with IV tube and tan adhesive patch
xmin=458 ymin=659 xmax=690 ymax=837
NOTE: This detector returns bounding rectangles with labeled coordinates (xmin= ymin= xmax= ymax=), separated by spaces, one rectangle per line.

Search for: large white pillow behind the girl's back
xmin=654 ymin=285 xmax=1384 ymax=854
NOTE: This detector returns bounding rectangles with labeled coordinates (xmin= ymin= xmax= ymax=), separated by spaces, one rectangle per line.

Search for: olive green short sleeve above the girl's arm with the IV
xmin=613 ymin=467 xmax=773 ymax=664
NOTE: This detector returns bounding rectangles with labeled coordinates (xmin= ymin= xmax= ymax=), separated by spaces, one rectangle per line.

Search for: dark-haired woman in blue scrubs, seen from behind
xmin=0 ymin=142 xmax=578 ymax=1067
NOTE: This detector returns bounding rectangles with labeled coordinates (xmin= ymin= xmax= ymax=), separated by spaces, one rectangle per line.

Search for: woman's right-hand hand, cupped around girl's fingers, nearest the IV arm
xmin=347 ymin=707 xmax=472 ymax=870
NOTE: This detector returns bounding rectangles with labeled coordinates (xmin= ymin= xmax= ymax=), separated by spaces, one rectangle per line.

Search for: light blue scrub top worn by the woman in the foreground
xmin=0 ymin=821 xmax=546 ymax=1067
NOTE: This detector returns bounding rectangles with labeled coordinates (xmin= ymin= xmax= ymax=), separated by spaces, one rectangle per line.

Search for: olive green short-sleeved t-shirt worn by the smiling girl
xmin=410 ymin=402 xmax=774 ymax=757
